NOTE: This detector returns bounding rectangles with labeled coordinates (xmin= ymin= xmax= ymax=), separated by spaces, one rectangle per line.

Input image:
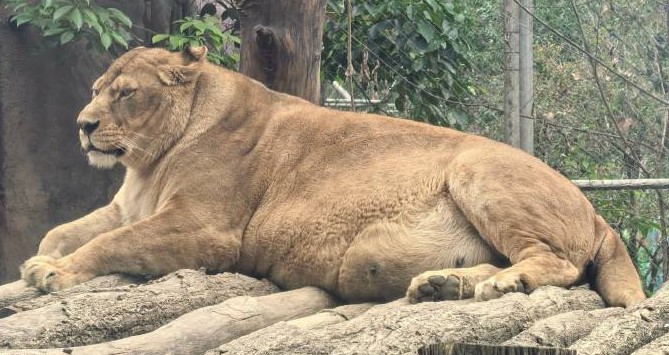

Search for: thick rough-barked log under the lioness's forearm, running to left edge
xmin=0 ymin=270 xmax=278 ymax=348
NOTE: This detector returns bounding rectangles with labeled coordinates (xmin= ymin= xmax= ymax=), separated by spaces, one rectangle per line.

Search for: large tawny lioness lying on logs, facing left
xmin=22 ymin=47 xmax=644 ymax=306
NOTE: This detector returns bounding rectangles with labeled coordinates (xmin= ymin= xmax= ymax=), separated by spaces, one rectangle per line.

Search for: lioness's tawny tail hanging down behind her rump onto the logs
xmin=590 ymin=216 xmax=646 ymax=307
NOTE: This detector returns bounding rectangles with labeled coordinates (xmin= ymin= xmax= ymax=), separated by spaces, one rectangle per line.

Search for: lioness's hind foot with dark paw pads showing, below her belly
xmin=406 ymin=264 xmax=500 ymax=303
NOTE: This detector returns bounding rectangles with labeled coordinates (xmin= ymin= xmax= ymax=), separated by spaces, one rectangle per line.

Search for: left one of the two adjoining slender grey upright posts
xmin=504 ymin=0 xmax=520 ymax=147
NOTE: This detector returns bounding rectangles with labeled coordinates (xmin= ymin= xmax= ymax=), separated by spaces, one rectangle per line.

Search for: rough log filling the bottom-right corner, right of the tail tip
xmin=569 ymin=283 xmax=669 ymax=355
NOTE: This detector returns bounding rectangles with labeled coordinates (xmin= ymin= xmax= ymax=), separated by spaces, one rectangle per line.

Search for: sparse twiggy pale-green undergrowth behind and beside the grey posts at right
xmin=454 ymin=0 xmax=669 ymax=291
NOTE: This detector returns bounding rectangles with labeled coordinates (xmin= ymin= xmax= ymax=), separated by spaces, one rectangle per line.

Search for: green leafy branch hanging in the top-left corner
xmin=6 ymin=0 xmax=132 ymax=50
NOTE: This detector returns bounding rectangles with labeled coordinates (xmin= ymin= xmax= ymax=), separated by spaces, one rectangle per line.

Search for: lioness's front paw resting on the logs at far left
xmin=21 ymin=255 xmax=95 ymax=292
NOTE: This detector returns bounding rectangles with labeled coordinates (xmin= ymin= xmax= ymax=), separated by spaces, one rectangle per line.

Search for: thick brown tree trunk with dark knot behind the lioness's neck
xmin=237 ymin=0 xmax=327 ymax=103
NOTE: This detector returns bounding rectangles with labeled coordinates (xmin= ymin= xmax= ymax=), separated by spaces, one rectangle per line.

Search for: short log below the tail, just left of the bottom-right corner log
xmin=502 ymin=307 xmax=625 ymax=348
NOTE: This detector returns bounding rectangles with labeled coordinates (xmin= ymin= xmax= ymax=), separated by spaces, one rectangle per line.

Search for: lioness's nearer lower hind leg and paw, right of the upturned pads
xmin=474 ymin=253 xmax=580 ymax=301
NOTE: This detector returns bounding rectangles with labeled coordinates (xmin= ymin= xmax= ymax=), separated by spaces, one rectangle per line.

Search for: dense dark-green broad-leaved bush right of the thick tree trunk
xmin=322 ymin=0 xmax=474 ymax=127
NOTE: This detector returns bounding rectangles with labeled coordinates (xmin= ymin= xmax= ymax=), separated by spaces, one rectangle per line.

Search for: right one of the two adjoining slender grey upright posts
xmin=519 ymin=0 xmax=534 ymax=155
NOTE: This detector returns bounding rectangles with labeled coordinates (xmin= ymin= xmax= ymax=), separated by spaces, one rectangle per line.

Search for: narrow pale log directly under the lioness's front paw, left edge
xmin=0 ymin=274 xmax=148 ymax=318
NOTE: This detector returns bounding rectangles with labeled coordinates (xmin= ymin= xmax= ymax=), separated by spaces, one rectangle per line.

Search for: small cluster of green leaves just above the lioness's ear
xmin=152 ymin=15 xmax=240 ymax=68
